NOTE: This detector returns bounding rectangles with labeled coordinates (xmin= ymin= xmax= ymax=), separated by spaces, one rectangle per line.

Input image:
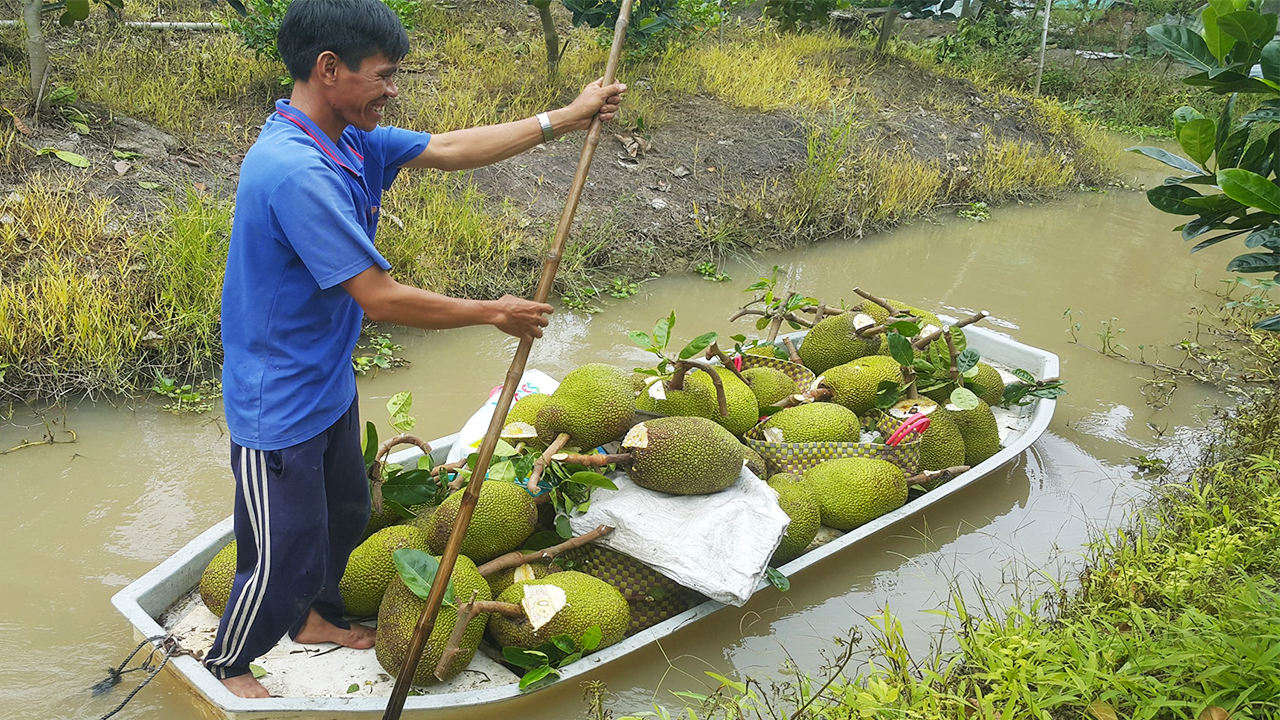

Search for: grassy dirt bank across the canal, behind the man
xmin=0 ymin=3 xmax=1115 ymax=400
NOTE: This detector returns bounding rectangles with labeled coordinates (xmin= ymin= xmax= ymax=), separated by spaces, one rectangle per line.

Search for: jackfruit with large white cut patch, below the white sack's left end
xmin=489 ymin=570 xmax=631 ymax=650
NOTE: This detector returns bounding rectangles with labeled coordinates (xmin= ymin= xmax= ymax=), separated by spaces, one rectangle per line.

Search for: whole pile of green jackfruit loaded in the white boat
xmin=200 ymin=294 xmax=1004 ymax=684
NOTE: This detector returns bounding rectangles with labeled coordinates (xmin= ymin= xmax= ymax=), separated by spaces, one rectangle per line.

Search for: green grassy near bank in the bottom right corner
xmin=622 ymin=302 xmax=1280 ymax=720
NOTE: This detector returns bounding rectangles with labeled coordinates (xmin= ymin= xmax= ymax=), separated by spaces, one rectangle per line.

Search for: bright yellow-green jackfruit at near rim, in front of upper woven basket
xmin=804 ymin=457 xmax=906 ymax=530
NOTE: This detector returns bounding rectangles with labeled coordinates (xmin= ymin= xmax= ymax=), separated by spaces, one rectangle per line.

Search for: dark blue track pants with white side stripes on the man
xmin=205 ymin=401 xmax=369 ymax=679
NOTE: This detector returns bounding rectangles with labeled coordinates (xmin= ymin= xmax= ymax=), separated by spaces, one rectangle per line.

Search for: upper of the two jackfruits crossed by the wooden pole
xmin=426 ymin=480 xmax=538 ymax=562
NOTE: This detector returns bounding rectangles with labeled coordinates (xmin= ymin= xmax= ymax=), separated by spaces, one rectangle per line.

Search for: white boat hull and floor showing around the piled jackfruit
xmin=111 ymin=327 xmax=1059 ymax=719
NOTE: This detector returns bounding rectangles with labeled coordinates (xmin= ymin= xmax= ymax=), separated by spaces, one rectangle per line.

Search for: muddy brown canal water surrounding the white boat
xmin=0 ymin=152 xmax=1234 ymax=720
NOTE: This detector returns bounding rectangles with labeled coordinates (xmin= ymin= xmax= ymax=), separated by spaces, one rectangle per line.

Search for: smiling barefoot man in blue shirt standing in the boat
xmin=205 ymin=0 xmax=626 ymax=697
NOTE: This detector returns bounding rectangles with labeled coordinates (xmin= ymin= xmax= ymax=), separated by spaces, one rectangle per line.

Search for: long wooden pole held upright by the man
xmin=383 ymin=0 xmax=632 ymax=720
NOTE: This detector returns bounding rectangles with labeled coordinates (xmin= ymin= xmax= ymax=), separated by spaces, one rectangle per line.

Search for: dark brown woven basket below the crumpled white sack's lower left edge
xmin=561 ymin=543 xmax=705 ymax=635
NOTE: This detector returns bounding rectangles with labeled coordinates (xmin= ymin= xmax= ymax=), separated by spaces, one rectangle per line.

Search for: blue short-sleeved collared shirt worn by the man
xmin=221 ymin=100 xmax=431 ymax=450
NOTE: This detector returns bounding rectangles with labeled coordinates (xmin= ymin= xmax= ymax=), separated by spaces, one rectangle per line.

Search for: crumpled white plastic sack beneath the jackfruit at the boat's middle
xmin=570 ymin=466 xmax=790 ymax=606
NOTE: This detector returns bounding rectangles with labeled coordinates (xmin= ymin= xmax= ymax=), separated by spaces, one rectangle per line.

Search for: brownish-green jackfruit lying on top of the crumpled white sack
xmin=622 ymin=418 xmax=742 ymax=495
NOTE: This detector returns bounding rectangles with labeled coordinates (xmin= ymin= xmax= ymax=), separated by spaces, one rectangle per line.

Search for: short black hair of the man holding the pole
xmin=276 ymin=0 xmax=408 ymax=82
